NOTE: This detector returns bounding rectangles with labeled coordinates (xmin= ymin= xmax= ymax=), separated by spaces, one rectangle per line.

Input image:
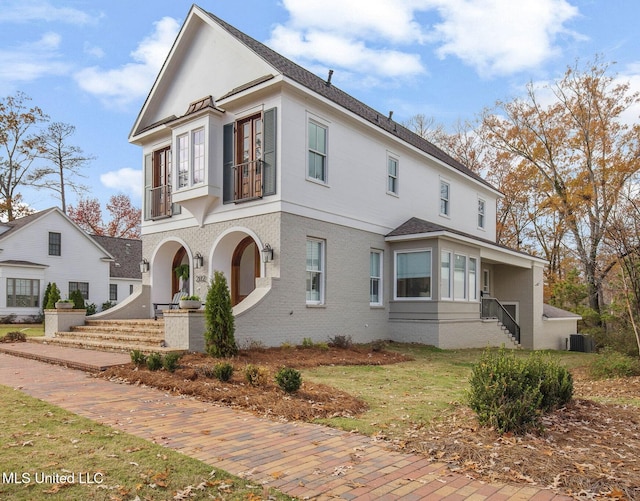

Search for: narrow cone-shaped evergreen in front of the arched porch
xmin=204 ymin=271 xmax=238 ymax=358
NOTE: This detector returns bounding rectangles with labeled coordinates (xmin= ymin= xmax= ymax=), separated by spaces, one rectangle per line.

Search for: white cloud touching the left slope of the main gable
xmin=74 ymin=17 xmax=180 ymax=107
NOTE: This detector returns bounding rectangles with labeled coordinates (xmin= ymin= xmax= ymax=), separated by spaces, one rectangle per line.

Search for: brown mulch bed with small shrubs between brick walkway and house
xmin=102 ymin=347 xmax=408 ymax=421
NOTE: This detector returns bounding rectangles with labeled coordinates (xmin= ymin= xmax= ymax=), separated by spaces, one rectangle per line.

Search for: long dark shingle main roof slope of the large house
xmin=200 ymin=8 xmax=496 ymax=190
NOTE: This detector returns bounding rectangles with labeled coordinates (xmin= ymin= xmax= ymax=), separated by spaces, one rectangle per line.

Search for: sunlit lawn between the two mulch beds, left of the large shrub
xmin=303 ymin=344 xmax=595 ymax=436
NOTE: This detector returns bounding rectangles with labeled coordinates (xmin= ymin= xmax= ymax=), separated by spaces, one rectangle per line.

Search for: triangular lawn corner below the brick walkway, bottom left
xmin=0 ymin=386 xmax=292 ymax=501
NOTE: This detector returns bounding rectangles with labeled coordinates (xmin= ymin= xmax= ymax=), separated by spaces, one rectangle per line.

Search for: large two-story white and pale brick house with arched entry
xmin=121 ymin=5 xmax=566 ymax=349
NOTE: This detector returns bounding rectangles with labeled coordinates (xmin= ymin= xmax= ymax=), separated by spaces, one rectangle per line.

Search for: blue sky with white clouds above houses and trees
xmin=0 ymin=0 xmax=640 ymax=210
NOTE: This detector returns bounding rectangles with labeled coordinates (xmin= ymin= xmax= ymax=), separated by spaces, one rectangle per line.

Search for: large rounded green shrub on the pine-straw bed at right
xmin=469 ymin=348 xmax=573 ymax=433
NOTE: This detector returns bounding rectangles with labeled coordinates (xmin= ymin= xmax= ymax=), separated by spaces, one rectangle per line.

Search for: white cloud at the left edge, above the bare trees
xmin=0 ymin=32 xmax=70 ymax=90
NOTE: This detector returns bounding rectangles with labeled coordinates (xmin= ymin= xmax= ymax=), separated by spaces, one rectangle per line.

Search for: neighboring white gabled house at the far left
xmin=0 ymin=207 xmax=113 ymax=321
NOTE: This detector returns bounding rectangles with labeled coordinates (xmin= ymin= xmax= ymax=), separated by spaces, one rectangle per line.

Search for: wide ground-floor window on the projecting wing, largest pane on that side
xmin=395 ymin=250 xmax=431 ymax=299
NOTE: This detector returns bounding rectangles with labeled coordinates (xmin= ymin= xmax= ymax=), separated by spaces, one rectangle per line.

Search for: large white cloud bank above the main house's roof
xmin=268 ymin=0 xmax=580 ymax=81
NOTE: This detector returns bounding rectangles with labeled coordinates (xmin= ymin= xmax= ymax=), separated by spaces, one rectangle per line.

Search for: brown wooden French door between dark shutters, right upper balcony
xmin=235 ymin=114 xmax=262 ymax=200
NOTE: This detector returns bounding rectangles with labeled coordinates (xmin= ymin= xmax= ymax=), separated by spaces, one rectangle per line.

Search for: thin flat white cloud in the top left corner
xmin=0 ymin=0 xmax=95 ymax=25
